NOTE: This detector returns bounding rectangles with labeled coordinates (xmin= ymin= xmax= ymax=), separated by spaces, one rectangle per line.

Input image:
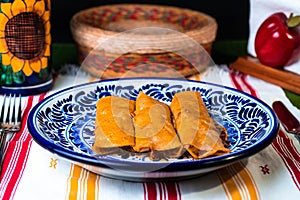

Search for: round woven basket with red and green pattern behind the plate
xmin=71 ymin=4 xmax=217 ymax=79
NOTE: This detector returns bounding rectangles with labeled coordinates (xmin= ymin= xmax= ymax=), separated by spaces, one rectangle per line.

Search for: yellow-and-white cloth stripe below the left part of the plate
xmin=66 ymin=164 xmax=100 ymax=200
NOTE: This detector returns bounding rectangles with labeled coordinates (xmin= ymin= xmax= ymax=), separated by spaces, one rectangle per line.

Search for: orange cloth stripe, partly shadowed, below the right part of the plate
xmin=217 ymin=162 xmax=260 ymax=200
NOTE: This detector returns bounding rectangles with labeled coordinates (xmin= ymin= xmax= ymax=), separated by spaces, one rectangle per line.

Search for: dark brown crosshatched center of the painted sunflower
xmin=5 ymin=12 xmax=45 ymax=60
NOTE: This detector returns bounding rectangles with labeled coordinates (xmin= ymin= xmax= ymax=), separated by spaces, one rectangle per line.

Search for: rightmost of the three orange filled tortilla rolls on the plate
xmin=170 ymin=91 xmax=230 ymax=159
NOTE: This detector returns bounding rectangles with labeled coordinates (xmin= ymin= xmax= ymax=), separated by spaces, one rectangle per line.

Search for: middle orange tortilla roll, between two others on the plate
xmin=133 ymin=92 xmax=182 ymax=158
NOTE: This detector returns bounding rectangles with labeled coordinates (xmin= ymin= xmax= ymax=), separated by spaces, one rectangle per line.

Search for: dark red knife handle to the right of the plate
xmin=272 ymin=101 xmax=300 ymax=142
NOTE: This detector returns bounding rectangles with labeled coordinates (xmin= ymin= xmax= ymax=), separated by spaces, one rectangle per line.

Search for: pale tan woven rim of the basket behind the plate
xmin=70 ymin=3 xmax=217 ymax=52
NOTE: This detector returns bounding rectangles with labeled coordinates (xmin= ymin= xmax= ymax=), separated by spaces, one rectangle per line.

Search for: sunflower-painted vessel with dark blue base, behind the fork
xmin=0 ymin=0 xmax=52 ymax=95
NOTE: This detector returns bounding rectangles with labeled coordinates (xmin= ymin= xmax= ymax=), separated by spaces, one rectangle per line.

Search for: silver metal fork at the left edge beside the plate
xmin=0 ymin=94 xmax=22 ymax=174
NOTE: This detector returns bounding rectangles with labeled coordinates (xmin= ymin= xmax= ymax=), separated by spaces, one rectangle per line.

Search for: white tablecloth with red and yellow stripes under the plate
xmin=0 ymin=65 xmax=300 ymax=200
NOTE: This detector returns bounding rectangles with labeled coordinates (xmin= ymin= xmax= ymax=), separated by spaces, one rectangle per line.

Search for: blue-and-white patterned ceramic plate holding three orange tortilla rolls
xmin=28 ymin=78 xmax=279 ymax=180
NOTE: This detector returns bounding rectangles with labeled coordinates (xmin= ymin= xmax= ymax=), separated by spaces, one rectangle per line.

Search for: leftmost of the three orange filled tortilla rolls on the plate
xmin=92 ymin=96 xmax=135 ymax=155
